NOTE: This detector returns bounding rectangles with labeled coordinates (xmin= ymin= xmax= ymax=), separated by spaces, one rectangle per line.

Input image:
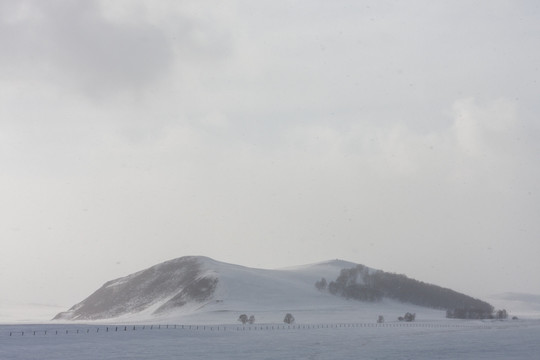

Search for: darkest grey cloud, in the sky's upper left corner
xmin=0 ymin=1 xmax=182 ymax=98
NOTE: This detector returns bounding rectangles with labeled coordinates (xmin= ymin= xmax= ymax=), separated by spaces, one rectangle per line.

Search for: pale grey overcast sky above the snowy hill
xmin=0 ymin=0 xmax=540 ymax=306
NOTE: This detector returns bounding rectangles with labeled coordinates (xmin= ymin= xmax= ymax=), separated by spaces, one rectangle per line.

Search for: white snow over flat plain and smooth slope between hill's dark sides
xmin=0 ymin=258 xmax=540 ymax=360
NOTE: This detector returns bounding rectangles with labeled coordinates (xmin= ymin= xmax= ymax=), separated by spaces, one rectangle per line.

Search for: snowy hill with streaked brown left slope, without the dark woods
xmin=53 ymin=256 xmax=492 ymax=321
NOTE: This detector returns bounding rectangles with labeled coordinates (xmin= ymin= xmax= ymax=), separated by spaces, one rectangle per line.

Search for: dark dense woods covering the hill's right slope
xmin=316 ymin=265 xmax=493 ymax=313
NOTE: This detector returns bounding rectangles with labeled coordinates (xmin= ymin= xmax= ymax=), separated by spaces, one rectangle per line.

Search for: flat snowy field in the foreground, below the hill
xmin=0 ymin=320 xmax=540 ymax=360
